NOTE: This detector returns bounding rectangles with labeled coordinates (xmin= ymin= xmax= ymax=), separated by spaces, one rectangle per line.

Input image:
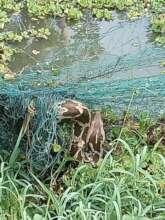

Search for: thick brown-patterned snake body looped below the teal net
xmin=59 ymin=100 xmax=105 ymax=163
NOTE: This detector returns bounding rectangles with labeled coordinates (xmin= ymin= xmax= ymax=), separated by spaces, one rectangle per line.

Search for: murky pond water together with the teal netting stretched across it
xmin=0 ymin=12 xmax=165 ymax=127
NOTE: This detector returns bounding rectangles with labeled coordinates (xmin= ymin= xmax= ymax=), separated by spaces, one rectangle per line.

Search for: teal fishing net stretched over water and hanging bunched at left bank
xmin=0 ymin=15 xmax=165 ymax=170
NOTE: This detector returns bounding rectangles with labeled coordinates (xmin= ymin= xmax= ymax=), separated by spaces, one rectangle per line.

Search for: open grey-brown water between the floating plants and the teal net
xmin=6 ymin=10 xmax=162 ymax=80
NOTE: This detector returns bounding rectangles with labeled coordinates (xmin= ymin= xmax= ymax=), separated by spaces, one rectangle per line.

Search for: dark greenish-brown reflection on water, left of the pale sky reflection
xmin=7 ymin=12 xmax=104 ymax=72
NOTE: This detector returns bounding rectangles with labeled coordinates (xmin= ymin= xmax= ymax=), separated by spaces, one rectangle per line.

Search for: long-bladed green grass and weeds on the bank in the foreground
xmin=0 ymin=112 xmax=165 ymax=220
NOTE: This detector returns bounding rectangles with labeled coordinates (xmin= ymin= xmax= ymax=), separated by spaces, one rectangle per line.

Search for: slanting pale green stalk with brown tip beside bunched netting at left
xmin=9 ymin=103 xmax=35 ymax=166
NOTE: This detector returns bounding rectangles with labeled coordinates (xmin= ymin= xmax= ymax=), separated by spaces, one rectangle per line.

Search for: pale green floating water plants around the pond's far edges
xmin=0 ymin=0 xmax=165 ymax=74
